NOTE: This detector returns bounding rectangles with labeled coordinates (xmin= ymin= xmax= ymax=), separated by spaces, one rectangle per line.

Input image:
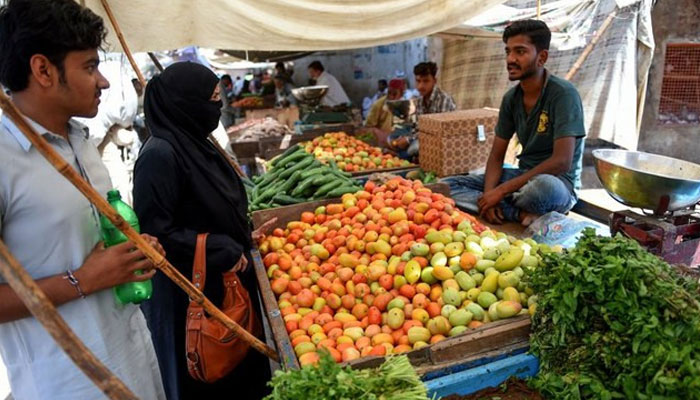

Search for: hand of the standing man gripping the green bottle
xmin=75 ymin=235 xmax=165 ymax=295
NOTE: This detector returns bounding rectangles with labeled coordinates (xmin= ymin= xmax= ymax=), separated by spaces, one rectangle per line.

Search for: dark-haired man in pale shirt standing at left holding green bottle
xmin=0 ymin=0 xmax=165 ymax=400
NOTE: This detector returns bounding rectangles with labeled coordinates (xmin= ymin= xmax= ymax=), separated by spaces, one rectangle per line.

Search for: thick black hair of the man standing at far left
xmin=0 ymin=0 xmax=107 ymax=92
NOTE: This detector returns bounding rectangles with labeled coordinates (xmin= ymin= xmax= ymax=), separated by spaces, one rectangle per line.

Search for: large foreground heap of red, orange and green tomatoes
xmin=259 ymin=178 xmax=548 ymax=365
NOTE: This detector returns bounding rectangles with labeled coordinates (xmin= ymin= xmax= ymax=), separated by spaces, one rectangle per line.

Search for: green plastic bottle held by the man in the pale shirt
xmin=100 ymin=189 xmax=153 ymax=305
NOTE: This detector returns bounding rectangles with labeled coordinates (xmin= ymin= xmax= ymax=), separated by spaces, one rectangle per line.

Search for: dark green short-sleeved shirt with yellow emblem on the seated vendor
xmin=496 ymin=72 xmax=586 ymax=189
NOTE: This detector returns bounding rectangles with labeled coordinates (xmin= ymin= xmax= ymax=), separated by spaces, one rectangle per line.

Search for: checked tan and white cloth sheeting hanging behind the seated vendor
xmin=440 ymin=0 xmax=654 ymax=150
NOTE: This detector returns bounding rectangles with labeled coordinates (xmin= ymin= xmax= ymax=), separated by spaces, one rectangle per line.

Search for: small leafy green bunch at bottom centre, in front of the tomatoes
xmin=265 ymin=353 xmax=427 ymax=400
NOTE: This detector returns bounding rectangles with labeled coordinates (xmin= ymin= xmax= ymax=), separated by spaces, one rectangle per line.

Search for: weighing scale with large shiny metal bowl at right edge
xmin=593 ymin=150 xmax=700 ymax=266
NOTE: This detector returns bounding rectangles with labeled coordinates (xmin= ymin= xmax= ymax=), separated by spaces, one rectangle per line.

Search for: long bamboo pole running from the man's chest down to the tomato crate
xmin=0 ymin=93 xmax=279 ymax=361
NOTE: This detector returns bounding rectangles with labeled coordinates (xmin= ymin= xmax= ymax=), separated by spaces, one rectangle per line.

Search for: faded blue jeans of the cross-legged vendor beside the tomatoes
xmin=442 ymin=168 xmax=578 ymax=222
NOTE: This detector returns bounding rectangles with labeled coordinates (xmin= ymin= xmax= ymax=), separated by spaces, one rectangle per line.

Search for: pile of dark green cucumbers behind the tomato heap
xmin=247 ymin=145 xmax=362 ymax=211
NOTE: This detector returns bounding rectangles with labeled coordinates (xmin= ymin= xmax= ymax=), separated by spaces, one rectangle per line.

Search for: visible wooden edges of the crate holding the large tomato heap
xmin=252 ymin=183 xmax=530 ymax=374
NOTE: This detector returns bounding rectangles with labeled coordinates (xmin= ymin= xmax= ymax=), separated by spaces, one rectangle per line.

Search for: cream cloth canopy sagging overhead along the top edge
xmin=83 ymin=0 xmax=504 ymax=52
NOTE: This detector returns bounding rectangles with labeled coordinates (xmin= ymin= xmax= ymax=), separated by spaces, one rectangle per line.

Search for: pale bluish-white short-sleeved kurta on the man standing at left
xmin=0 ymin=117 xmax=165 ymax=400
